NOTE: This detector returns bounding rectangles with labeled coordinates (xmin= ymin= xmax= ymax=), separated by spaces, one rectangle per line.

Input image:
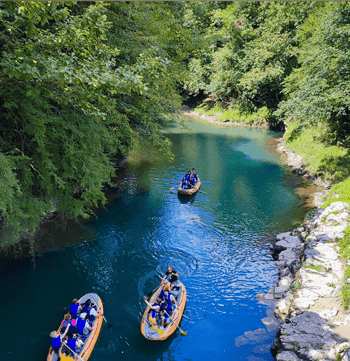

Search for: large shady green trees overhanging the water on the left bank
xmin=0 ymin=2 xmax=196 ymax=245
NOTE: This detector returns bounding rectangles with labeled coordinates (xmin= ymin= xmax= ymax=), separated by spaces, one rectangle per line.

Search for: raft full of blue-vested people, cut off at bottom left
xmin=47 ymin=293 xmax=104 ymax=361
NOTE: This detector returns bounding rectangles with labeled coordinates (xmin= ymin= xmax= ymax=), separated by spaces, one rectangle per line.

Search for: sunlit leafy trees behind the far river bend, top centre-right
xmin=186 ymin=2 xmax=315 ymax=116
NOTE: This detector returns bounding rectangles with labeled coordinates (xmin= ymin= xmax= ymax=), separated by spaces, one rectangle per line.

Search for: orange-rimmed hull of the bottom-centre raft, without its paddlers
xmin=141 ymin=282 xmax=187 ymax=341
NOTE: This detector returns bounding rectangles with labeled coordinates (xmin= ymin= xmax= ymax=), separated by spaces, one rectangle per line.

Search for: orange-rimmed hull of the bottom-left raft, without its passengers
xmin=47 ymin=293 xmax=103 ymax=361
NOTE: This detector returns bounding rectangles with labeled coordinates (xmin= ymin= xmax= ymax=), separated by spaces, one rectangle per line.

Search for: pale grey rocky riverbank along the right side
xmin=258 ymin=140 xmax=350 ymax=361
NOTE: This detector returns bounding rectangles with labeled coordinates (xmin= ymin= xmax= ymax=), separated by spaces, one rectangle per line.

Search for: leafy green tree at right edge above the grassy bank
xmin=275 ymin=2 xmax=350 ymax=146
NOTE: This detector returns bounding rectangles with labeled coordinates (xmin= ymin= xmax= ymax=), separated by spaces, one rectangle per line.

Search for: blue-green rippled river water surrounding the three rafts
xmin=0 ymin=119 xmax=301 ymax=361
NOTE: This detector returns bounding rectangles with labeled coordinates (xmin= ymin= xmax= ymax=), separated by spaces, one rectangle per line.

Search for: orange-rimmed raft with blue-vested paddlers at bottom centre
xmin=141 ymin=281 xmax=187 ymax=341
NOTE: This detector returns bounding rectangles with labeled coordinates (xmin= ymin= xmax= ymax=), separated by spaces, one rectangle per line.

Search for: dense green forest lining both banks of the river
xmin=0 ymin=1 xmax=350 ymax=245
